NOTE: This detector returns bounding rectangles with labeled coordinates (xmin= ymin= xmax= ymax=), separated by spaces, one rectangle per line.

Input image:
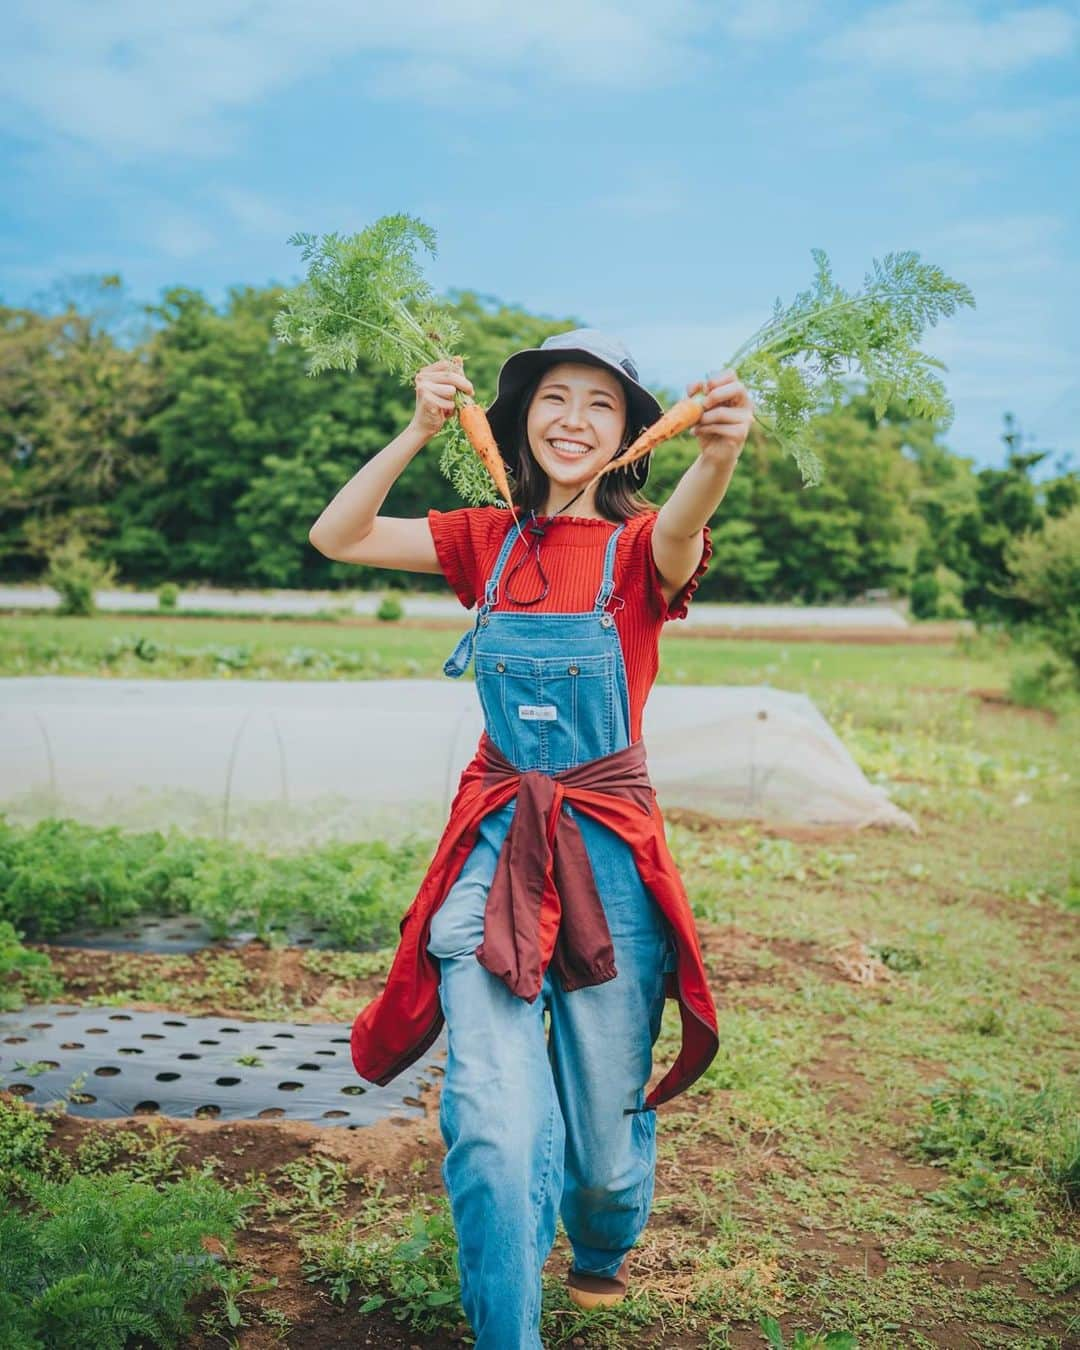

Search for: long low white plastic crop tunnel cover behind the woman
xmin=0 ymin=676 xmax=917 ymax=848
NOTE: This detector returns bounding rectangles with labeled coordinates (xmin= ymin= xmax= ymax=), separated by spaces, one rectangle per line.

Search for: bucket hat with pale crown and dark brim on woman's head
xmin=487 ymin=328 xmax=663 ymax=489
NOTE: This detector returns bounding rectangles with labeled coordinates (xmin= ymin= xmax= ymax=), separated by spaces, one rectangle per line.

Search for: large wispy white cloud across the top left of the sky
xmin=0 ymin=0 xmax=711 ymax=159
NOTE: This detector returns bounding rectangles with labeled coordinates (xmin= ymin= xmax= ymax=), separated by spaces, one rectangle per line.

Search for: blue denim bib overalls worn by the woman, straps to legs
xmin=428 ymin=513 xmax=675 ymax=1350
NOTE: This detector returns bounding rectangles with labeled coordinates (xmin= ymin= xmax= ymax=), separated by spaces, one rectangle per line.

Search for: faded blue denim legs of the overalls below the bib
xmin=428 ymin=802 xmax=675 ymax=1350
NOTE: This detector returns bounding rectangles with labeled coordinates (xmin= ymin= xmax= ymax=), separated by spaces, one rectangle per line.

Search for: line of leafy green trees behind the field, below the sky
xmin=0 ymin=277 xmax=1080 ymax=620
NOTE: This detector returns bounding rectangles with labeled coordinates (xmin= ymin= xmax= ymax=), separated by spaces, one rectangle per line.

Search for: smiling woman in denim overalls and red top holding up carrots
xmin=311 ymin=329 xmax=753 ymax=1350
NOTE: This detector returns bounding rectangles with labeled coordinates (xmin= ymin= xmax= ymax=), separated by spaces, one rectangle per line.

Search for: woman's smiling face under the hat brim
xmin=527 ymin=360 xmax=626 ymax=487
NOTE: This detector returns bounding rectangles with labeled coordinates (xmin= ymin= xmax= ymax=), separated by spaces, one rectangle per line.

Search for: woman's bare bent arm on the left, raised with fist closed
xmin=308 ymin=360 xmax=473 ymax=572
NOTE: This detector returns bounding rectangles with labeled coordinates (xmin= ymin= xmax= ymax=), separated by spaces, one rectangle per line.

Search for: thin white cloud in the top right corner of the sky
xmin=818 ymin=0 xmax=1080 ymax=84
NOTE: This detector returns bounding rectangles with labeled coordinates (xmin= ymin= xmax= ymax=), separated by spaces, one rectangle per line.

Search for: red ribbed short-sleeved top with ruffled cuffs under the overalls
xmin=428 ymin=506 xmax=713 ymax=741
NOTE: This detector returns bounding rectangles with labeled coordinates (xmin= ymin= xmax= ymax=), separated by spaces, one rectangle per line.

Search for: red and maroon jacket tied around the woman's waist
xmin=351 ymin=733 xmax=718 ymax=1107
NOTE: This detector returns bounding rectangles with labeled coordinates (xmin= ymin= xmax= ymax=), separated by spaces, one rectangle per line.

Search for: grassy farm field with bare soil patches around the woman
xmin=0 ymin=617 xmax=1080 ymax=1350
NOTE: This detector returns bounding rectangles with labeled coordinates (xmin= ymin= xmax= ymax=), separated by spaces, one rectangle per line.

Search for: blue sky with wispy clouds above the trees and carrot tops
xmin=0 ymin=0 xmax=1080 ymax=470
